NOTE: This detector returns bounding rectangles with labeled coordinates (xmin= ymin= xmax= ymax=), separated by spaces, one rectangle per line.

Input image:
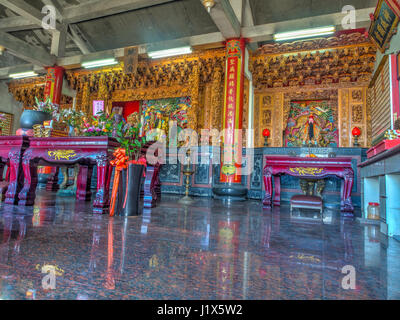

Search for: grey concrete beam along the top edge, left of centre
xmin=62 ymin=0 xmax=175 ymax=23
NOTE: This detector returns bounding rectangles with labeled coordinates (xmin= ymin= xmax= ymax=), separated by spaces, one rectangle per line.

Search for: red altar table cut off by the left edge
xmin=0 ymin=136 xmax=29 ymax=204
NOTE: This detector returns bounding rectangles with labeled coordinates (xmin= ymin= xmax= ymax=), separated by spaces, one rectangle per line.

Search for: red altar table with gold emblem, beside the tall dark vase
xmin=18 ymin=137 xmax=120 ymax=213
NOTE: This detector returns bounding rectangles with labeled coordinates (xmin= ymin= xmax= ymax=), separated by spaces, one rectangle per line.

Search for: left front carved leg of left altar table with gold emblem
xmin=18 ymin=149 xmax=38 ymax=206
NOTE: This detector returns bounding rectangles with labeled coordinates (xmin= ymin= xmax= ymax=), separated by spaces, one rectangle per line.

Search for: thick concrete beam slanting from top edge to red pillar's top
xmin=199 ymin=0 xmax=241 ymax=39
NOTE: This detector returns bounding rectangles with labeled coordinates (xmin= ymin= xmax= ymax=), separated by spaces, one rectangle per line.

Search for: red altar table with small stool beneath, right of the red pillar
xmin=263 ymin=156 xmax=354 ymax=212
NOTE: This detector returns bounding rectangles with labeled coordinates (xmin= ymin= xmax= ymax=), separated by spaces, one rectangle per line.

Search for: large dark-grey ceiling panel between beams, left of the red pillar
xmin=77 ymin=0 xmax=218 ymax=50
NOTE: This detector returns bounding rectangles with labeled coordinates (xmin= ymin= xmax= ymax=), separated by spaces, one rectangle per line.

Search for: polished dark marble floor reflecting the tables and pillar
xmin=0 ymin=191 xmax=400 ymax=300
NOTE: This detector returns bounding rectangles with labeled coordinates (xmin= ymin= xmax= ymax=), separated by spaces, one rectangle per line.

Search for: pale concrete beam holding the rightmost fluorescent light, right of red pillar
xmin=242 ymin=7 xmax=375 ymax=42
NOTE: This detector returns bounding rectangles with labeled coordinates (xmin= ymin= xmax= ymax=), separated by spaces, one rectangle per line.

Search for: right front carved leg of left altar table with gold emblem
xmin=93 ymin=154 xmax=112 ymax=213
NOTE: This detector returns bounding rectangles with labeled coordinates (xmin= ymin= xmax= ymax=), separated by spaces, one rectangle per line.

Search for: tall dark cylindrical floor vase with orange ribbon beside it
xmin=121 ymin=163 xmax=144 ymax=217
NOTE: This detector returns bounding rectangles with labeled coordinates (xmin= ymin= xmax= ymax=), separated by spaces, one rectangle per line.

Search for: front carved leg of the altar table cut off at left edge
xmin=5 ymin=149 xmax=24 ymax=204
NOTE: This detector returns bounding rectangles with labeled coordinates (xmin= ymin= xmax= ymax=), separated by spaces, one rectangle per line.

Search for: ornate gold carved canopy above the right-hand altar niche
xmin=251 ymin=35 xmax=376 ymax=89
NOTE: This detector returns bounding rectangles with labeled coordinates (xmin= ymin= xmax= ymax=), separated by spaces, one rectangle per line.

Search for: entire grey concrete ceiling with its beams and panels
xmin=0 ymin=0 xmax=377 ymax=76
